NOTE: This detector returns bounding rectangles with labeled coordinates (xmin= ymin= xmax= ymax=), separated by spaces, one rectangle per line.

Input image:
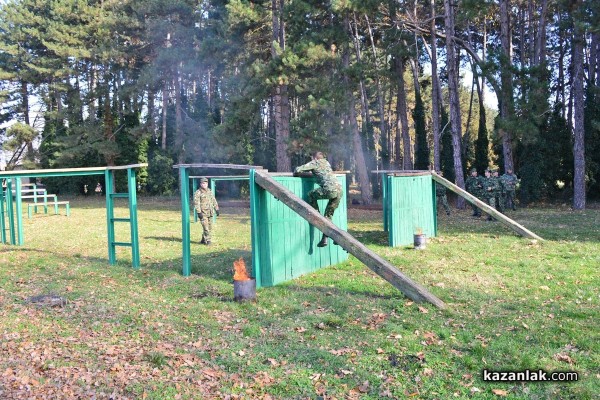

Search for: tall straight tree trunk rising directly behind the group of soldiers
xmin=496 ymin=0 xmax=514 ymax=171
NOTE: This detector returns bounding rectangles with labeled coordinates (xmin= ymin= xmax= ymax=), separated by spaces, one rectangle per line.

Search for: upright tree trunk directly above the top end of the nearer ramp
xmin=271 ymin=0 xmax=292 ymax=172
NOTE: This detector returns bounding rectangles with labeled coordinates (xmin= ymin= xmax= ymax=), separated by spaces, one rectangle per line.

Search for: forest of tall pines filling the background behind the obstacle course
xmin=0 ymin=0 xmax=600 ymax=209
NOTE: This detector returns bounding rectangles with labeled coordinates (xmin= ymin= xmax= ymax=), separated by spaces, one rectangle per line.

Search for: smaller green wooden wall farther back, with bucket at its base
xmin=383 ymin=174 xmax=437 ymax=246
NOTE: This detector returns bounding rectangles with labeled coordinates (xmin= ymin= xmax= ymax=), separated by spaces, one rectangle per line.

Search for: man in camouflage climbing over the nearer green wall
xmin=294 ymin=151 xmax=343 ymax=247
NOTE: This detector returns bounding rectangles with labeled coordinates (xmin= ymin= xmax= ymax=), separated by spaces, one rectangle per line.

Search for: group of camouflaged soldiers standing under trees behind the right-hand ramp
xmin=435 ymin=168 xmax=519 ymax=221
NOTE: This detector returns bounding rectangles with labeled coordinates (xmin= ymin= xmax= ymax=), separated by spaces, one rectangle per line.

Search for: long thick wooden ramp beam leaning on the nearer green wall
xmin=254 ymin=170 xmax=446 ymax=308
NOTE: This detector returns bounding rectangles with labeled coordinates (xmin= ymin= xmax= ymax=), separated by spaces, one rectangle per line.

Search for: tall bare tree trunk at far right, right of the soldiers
xmin=572 ymin=18 xmax=586 ymax=210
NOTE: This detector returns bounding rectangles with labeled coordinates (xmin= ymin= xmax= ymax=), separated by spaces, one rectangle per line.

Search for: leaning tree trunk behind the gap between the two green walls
xmin=343 ymin=50 xmax=373 ymax=204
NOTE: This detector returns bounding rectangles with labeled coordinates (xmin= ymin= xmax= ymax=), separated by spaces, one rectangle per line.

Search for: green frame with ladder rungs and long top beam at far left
xmin=0 ymin=164 xmax=148 ymax=269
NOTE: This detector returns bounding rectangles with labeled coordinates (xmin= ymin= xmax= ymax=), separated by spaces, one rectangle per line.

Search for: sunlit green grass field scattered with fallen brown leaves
xmin=0 ymin=198 xmax=600 ymax=399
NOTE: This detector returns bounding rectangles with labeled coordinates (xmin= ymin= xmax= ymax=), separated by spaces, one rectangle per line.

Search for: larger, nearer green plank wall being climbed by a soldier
xmin=250 ymin=175 xmax=348 ymax=286
